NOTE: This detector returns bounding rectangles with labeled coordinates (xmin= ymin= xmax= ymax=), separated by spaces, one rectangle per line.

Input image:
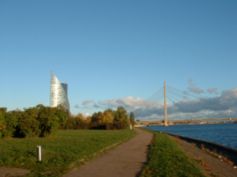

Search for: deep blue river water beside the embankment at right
xmin=148 ymin=124 xmax=237 ymax=149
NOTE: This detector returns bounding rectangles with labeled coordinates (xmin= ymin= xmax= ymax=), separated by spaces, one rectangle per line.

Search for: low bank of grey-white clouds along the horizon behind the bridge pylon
xmin=77 ymin=88 xmax=237 ymax=119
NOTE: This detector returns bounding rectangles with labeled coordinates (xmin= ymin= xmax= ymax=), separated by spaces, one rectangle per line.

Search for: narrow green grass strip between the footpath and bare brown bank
xmin=141 ymin=133 xmax=204 ymax=177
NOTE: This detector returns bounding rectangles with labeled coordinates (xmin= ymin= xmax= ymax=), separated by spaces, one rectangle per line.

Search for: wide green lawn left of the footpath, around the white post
xmin=0 ymin=130 xmax=134 ymax=177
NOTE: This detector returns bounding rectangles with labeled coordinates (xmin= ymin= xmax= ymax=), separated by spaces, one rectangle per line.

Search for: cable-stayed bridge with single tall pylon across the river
xmin=142 ymin=81 xmax=237 ymax=126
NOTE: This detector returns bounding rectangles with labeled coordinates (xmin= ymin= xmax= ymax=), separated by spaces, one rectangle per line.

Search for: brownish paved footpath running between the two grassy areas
xmin=63 ymin=129 xmax=152 ymax=177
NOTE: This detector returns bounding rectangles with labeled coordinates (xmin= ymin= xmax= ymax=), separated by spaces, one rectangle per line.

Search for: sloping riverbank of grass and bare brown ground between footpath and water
xmin=141 ymin=132 xmax=237 ymax=177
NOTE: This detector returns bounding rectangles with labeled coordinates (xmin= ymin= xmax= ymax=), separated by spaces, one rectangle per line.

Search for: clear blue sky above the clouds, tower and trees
xmin=0 ymin=0 xmax=237 ymax=118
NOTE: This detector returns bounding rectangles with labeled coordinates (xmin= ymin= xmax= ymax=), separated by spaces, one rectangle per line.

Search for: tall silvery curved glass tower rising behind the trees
xmin=50 ymin=74 xmax=70 ymax=111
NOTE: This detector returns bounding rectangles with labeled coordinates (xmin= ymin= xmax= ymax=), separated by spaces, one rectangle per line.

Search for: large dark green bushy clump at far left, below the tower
xmin=0 ymin=105 xmax=69 ymax=138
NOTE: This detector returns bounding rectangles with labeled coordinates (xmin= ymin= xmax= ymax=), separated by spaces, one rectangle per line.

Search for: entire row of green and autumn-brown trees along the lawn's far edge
xmin=0 ymin=105 xmax=135 ymax=138
